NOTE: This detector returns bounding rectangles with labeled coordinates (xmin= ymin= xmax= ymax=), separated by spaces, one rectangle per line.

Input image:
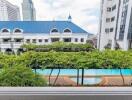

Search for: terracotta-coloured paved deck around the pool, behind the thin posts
xmin=43 ymin=76 xmax=132 ymax=86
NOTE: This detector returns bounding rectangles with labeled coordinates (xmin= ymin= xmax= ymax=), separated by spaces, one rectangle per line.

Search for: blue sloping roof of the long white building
xmin=0 ymin=21 xmax=88 ymax=34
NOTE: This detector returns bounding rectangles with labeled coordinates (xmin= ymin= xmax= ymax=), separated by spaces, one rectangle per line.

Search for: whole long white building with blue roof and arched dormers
xmin=0 ymin=21 xmax=89 ymax=52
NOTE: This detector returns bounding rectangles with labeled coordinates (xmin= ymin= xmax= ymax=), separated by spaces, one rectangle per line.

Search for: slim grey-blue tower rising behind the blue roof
xmin=22 ymin=0 xmax=36 ymax=21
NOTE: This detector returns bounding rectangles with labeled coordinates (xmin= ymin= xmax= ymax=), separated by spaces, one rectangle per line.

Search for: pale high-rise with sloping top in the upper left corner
xmin=0 ymin=0 xmax=20 ymax=21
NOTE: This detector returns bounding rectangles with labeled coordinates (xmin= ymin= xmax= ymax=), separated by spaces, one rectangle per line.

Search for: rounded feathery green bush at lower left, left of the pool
xmin=0 ymin=65 xmax=47 ymax=87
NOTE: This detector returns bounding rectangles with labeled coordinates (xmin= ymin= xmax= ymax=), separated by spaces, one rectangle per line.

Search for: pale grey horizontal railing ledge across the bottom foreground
xmin=0 ymin=87 xmax=132 ymax=95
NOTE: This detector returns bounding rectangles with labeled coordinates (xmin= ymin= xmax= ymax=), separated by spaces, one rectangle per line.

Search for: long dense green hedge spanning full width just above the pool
xmin=0 ymin=50 xmax=132 ymax=69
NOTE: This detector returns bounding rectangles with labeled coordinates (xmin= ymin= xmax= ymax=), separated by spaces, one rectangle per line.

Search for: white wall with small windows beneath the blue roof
xmin=0 ymin=32 xmax=88 ymax=52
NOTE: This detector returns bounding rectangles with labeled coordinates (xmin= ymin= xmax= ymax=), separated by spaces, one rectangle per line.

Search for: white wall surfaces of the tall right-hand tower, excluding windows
xmin=98 ymin=0 xmax=132 ymax=50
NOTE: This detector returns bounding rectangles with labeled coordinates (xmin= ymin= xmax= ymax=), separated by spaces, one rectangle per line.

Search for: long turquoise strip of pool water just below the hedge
xmin=37 ymin=69 xmax=132 ymax=76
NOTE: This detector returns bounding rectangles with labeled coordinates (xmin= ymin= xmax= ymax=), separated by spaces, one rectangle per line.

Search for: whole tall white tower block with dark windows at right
xmin=98 ymin=0 xmax=132 ymax=50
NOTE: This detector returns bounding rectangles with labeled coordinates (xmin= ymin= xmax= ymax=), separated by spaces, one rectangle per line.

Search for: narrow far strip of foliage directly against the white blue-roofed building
xmin=22 ymin=42 xmax=95 ymax=52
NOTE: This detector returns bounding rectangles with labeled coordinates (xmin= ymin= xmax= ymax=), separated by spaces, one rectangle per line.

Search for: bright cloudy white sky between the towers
xmin=7 ymin=0 xmax=100 ymax=34
